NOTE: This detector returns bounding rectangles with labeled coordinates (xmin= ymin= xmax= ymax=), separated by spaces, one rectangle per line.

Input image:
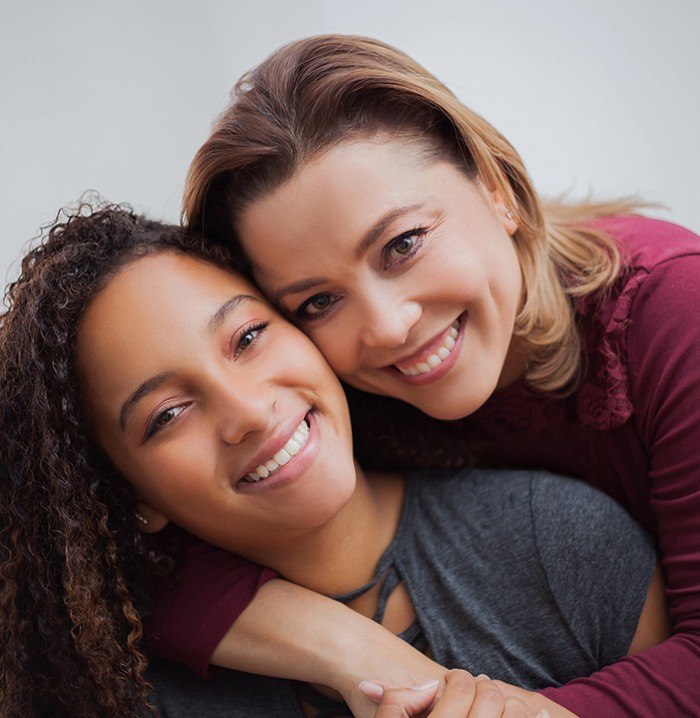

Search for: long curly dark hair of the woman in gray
xmin=0 ymin=199 xmax=235 ymax=718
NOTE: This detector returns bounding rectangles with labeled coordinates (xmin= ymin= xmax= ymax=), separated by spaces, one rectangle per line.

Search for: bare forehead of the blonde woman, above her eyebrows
xmin=237 ymin=134 xmax=456 ymax=258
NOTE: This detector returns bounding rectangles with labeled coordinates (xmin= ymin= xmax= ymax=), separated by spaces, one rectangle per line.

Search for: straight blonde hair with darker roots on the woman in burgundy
xmin=183 ymin=35 xmax=639 ymax=393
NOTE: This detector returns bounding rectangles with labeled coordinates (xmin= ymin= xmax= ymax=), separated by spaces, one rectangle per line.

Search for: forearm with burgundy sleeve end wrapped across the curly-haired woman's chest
xmin=145 ymin=542 xmax=445 ymax=716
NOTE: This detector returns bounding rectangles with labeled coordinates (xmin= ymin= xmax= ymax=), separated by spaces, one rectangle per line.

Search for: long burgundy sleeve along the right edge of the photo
xmin=542 ymin=254 xmax=700 ymax=718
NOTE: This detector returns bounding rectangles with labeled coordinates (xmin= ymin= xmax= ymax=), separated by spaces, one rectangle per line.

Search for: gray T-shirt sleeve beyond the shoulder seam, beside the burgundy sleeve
xmin=532 ymin=475 xmax=655 ymax=666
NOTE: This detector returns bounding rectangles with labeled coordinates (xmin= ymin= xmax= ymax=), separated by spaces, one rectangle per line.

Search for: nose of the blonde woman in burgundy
xmin=360 ymin=292 xmax=422 ymax=349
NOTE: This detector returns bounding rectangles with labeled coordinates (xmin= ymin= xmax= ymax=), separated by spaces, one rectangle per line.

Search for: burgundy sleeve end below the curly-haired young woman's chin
xmin=144 ymin=540 xmax=277 ymax=676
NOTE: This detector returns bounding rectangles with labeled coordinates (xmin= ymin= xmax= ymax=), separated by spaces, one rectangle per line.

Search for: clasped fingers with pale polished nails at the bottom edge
xmin=363 ymin=670 xmax=549 ymax=718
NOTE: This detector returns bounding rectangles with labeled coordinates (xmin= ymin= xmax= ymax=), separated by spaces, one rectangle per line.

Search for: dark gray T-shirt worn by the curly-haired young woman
xmin=150 ymin=470 xmax=655 ymax=718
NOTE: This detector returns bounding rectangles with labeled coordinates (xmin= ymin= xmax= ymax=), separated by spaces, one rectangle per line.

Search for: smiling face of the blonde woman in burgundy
xmin=237 ymin=134 xmax=524 ymax=419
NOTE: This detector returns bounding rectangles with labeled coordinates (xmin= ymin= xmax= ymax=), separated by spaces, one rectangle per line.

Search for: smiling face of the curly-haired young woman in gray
xmin=77 ymin=252 xmax=355 ymax=560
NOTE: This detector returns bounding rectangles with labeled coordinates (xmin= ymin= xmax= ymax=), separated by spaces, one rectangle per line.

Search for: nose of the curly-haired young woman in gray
xmin=216 ymin=376 xmax=277 ymax=445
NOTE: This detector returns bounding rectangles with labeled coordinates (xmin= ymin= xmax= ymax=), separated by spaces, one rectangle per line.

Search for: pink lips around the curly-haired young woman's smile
xmin=235 ymin=409 xmax=321 ymax=494
